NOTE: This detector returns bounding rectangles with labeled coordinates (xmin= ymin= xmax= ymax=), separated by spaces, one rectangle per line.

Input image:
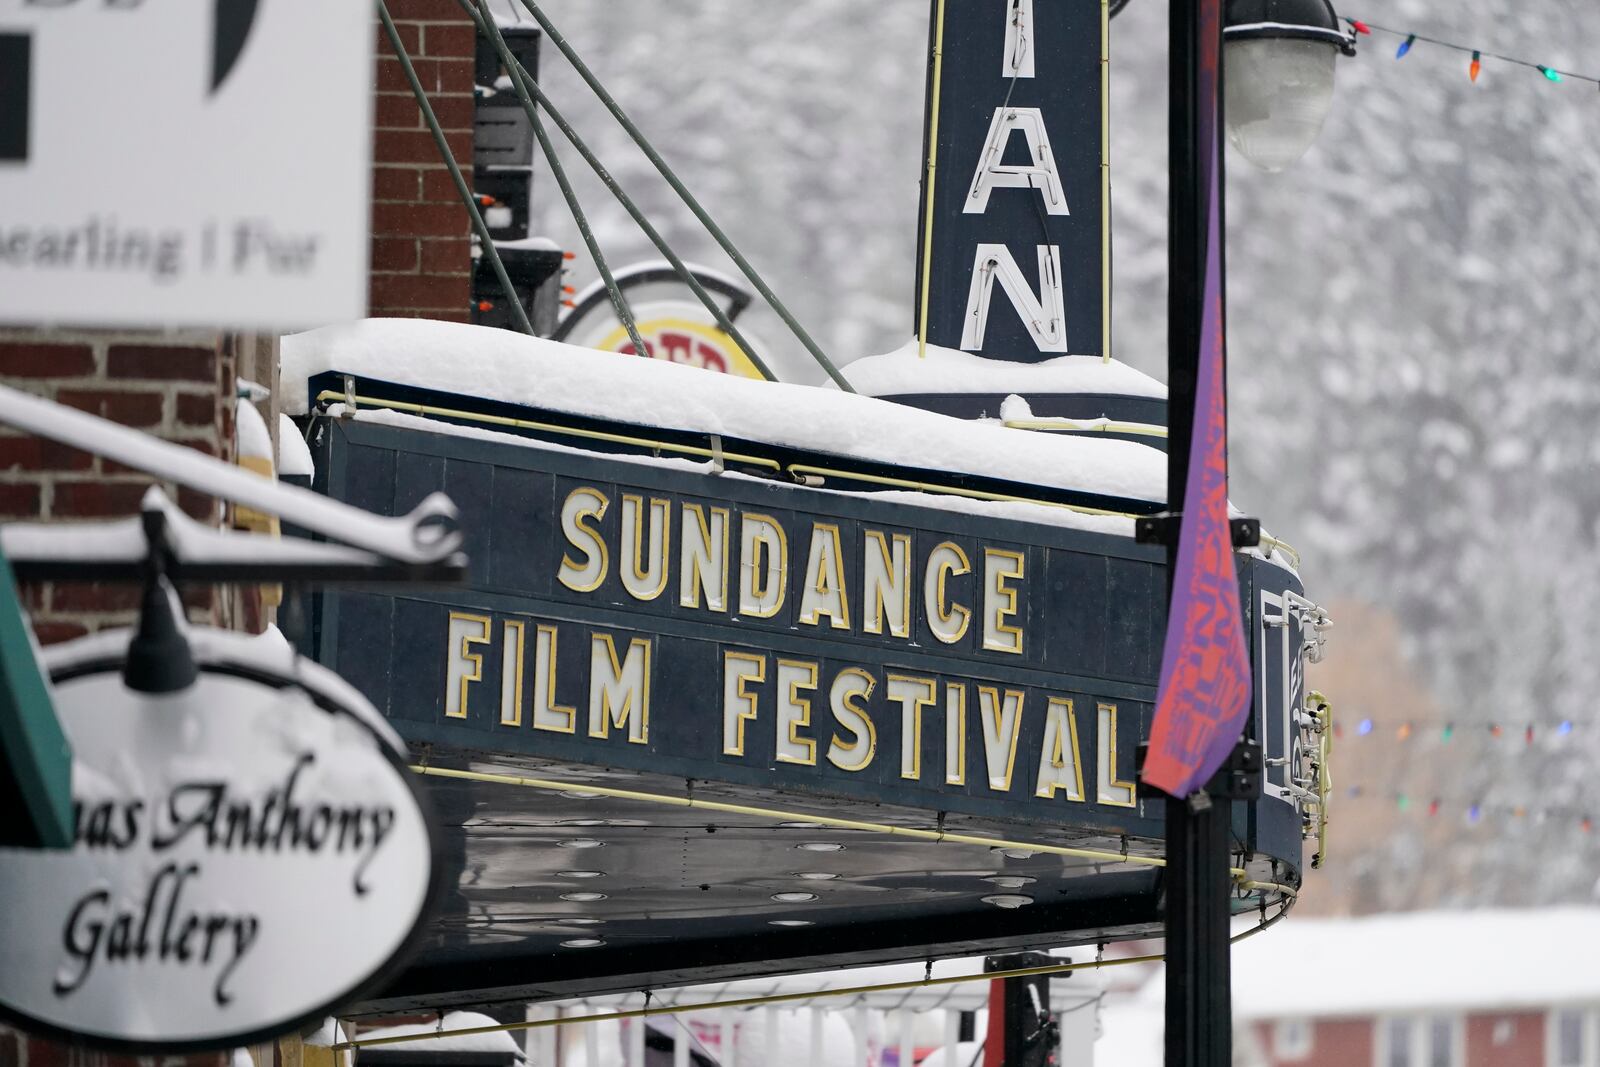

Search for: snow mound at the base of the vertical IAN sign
xmin=843 ymin=338 xmax=1166 ymax=400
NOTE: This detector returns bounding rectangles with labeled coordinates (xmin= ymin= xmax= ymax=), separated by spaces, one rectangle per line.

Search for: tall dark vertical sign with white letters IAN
xmin=915 ymin=0 xmax=1110 ymax=363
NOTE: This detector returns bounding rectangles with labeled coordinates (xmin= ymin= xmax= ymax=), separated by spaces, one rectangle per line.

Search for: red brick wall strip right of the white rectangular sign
xmin=368 ymin=0 xmax=475 ymax=322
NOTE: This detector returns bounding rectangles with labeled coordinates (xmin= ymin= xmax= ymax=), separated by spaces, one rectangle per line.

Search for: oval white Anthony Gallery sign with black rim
xmin=0 ymin=632 xmax=432 ymax=1051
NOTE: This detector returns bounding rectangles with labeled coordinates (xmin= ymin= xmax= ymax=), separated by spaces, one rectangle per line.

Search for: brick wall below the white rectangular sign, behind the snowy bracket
xmin=0 ymin=331 xmax=238 ymax=643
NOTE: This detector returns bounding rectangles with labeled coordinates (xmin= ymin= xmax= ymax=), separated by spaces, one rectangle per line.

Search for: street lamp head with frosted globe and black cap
xmin=1222 ymin=0 xmax=1355 ymax=173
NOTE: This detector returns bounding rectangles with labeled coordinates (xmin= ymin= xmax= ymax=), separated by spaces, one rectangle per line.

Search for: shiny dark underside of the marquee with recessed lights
xmin=354 ymin=750 xmax=1162 ymax=1014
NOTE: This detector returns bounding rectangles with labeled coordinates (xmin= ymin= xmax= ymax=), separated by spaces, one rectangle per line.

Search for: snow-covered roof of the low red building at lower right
xmin=1138 ymin=907 xmax=1600 ymax=1019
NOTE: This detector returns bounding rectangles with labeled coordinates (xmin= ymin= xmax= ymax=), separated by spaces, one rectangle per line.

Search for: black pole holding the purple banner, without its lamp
xmin=1166 ymin=0 xmax=1234 ymax=1067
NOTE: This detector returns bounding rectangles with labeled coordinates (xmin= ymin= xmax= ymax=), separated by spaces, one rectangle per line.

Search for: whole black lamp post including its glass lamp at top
xmin=1165 ymin=0 xmax=1354 ymax=1067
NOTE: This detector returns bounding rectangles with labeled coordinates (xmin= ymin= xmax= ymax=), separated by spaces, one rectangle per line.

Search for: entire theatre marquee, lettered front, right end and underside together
xmin=300 ymin=385 xmax=1302 ymax=1011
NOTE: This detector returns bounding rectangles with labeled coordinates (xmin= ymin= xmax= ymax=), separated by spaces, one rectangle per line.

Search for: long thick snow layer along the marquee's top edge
xmin=280 ymin=318 xmax=1166 ymax=501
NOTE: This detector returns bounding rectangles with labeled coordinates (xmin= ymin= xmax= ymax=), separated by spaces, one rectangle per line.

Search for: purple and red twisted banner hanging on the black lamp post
xmin=1144 ymin=0 xmax=1251 ymax=797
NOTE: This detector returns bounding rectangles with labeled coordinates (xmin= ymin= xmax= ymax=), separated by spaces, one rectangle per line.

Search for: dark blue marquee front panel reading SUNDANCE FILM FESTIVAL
xmin=308 ymin=409 xmax=1298 ymax=832
